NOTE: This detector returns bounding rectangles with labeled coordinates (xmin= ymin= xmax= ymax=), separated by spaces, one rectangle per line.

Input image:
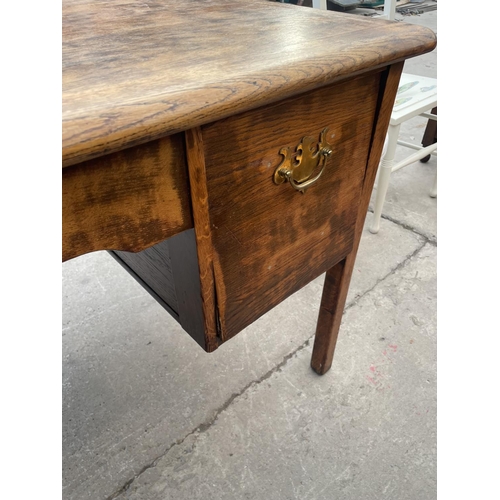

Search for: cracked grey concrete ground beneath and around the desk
xmin=63 ymin=11 xmax=437 ymax=500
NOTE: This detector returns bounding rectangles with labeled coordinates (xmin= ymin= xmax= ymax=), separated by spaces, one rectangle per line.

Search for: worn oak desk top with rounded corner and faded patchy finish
xmin=62 ymin=0 xmax=436 ymax=166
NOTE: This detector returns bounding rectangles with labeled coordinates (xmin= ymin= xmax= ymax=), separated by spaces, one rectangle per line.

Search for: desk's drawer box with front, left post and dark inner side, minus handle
xmin=113 ymin=72 xmax=382 ymax=351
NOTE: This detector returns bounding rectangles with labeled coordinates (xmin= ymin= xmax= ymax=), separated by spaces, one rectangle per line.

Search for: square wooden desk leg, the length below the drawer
xmin=311 ymin=256 xmax=354 ymax=375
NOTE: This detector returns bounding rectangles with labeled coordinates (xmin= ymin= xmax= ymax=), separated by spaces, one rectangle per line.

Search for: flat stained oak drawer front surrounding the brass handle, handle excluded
xmin=202 ymin=72 xmax=380 ymax=341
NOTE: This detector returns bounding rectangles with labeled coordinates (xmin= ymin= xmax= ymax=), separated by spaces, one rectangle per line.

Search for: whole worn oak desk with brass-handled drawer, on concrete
xmin=62 ymin=0 xmax=436 ymax=374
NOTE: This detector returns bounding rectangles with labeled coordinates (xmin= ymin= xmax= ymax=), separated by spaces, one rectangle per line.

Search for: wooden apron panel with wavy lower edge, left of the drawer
xmin=62 ymin=134 xmax=193 ymax=261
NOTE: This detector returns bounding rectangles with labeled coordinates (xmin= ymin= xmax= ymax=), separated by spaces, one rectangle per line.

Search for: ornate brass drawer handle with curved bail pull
xmin=274 ymin=128 xmax=333 ymax=193
